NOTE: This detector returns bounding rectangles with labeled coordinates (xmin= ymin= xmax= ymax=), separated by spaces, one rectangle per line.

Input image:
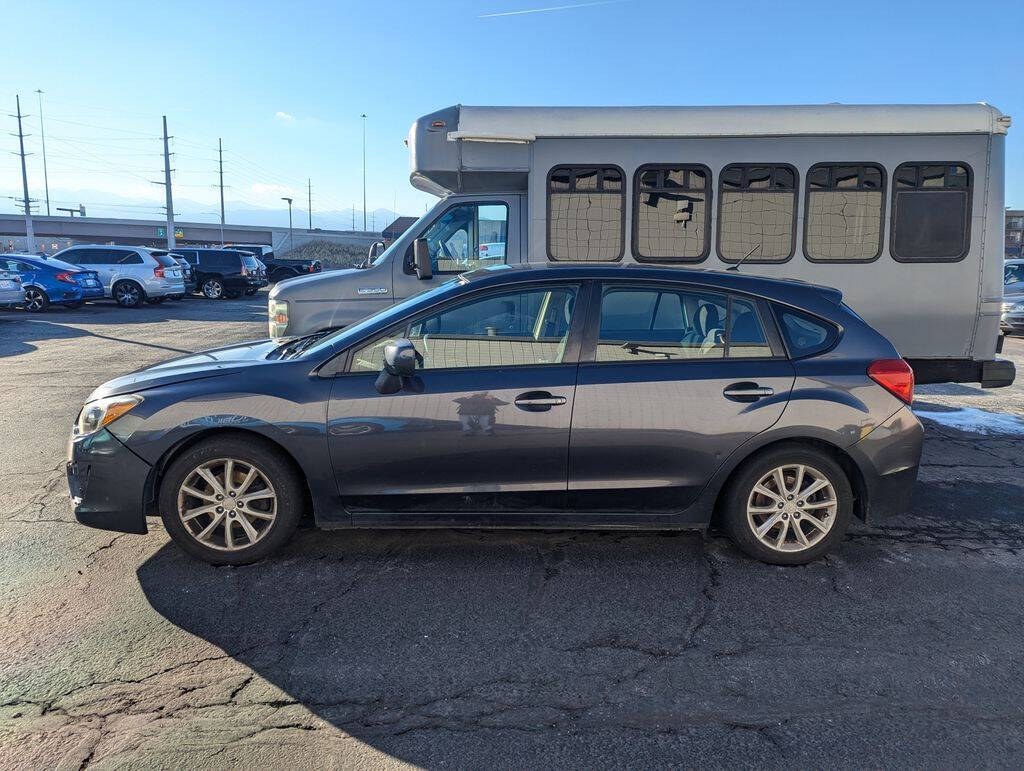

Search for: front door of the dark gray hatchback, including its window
xmin=328 ymin=284 xmax=581 ymax=514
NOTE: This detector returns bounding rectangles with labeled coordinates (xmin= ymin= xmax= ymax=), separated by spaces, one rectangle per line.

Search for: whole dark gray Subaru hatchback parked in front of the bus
xmin=68 ymin=265 xmax=923 ymax=564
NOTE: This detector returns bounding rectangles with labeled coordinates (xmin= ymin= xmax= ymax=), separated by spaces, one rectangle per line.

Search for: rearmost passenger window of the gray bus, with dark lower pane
xmin=890 ymin=163 xmax=972 ymax=262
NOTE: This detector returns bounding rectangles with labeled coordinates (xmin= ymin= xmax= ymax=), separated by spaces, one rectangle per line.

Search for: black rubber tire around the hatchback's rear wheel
xmin=721 ymin=444 xmax=853 ymax=565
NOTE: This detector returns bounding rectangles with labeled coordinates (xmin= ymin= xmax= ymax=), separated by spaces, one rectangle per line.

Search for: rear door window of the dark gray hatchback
xmin=596 ymin=287 xmax=772 ymax=361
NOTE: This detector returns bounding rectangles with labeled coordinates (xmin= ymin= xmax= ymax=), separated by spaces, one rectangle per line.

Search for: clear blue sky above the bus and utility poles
xmin=0 ymin=0 xmax=1024 ymax=221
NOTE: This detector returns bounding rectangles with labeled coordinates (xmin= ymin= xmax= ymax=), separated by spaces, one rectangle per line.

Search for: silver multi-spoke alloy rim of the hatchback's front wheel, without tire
xmin=177 ymin=458 xmax=278 ymax=552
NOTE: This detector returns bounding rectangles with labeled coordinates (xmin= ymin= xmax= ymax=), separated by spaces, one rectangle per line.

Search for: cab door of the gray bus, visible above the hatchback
xmin=393 ymin=196 xmax=521 ymax=302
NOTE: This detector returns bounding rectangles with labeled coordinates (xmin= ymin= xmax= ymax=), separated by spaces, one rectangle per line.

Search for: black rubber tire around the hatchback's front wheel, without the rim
xmin=159 ymin=435 xmax=305 ymax=565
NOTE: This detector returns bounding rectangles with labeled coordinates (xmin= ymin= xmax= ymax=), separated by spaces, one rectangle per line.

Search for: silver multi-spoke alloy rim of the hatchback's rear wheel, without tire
xmin=746 ymin=464 xmax=839 ymax=552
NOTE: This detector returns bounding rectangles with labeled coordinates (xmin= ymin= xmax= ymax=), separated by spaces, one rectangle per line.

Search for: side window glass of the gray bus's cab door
xmin=407 ymin=204 xmax=509 ymax=273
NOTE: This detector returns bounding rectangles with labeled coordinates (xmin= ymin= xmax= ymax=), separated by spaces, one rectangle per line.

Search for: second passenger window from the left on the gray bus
xmin=633 ymin=166 xmax=711 ymax=262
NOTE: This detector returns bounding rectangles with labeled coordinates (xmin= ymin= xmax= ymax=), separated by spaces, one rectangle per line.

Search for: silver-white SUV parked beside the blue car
xmin=53 ymin=245 xmax=185 ymax=308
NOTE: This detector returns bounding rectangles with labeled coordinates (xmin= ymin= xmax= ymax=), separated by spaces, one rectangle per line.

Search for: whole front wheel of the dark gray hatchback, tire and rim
xmin=160 ymin=437 xmax=304 ymax=565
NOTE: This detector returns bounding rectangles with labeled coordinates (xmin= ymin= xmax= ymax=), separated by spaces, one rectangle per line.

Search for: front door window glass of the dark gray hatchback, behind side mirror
xmin=350 ymin=285 xmax=580 ymax=372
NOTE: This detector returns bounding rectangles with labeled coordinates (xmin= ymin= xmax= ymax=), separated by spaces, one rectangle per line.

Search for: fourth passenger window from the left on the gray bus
xmin=804 ymin=164 xmax=885 ymax=261
